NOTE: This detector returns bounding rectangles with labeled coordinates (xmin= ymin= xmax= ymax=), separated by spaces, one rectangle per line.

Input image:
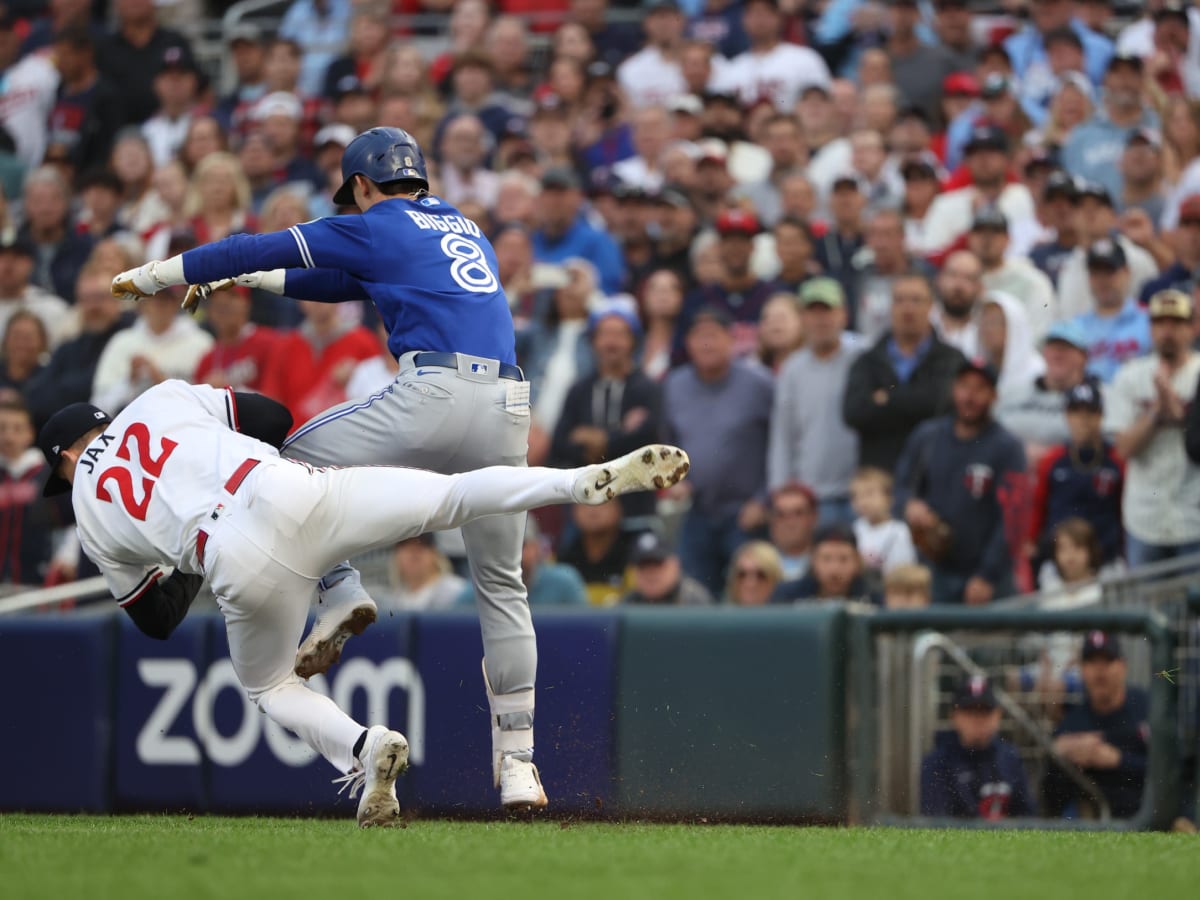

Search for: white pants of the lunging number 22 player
xmin=203 ymin=458 xmax=577 ymax=773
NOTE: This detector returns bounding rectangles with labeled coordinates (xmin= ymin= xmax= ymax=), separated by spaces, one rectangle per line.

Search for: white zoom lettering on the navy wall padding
xmin=137 ymin=658 xmax=425 ymax=767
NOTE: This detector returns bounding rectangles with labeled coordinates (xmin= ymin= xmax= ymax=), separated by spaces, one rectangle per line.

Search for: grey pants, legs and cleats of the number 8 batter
xmin=283 ymin=354 xmax=545 ymax=806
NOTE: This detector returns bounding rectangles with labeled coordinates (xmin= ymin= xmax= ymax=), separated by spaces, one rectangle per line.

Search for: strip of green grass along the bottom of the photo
xmin=0 ymin=815 xmax=1200 ymax=900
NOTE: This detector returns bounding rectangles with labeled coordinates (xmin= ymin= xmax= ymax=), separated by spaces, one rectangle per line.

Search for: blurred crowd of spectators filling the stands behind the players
xmin=0 ymin=0 xmax=1200 ymax=628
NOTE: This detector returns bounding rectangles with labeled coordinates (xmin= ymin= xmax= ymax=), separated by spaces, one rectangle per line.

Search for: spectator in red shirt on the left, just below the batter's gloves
xmin=192 ymin=288 xmax=280 ymax=391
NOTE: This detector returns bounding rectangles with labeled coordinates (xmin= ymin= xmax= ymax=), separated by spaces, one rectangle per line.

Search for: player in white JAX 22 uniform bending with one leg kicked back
xmin=38 ymin=380 xmax=688 ymax=827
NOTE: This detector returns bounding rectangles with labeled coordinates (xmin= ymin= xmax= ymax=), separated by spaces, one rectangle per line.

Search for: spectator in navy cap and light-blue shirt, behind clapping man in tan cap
xmin=1070 ymin=238 xmax=1151 ymax=384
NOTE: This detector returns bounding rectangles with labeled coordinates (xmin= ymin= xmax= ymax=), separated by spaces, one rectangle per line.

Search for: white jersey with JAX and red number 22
xmin=71 ymin=380 xmax=278 ymax=606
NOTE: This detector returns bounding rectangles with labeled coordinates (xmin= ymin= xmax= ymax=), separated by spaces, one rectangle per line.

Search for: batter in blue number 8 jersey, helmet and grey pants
xmin=113 ymin=128 xmax=561 ymax=809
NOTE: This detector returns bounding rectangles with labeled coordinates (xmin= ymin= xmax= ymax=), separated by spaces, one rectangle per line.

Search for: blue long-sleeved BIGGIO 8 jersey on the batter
xmin=184 ymin=197 xmax=516 ymax=364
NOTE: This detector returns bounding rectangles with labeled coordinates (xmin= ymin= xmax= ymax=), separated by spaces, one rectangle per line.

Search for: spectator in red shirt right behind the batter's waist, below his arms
xmin=260 ymin=301 xmax=379 ymax=427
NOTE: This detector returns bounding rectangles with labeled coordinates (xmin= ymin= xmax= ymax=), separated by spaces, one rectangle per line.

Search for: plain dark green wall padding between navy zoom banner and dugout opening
xmin=616 ymin=605 xmax=846 ymax=820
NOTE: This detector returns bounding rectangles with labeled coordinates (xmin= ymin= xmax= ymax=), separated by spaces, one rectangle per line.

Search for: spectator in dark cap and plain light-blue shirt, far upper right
xmin=1062 ymin=56 xmax=1158 ymax=197
